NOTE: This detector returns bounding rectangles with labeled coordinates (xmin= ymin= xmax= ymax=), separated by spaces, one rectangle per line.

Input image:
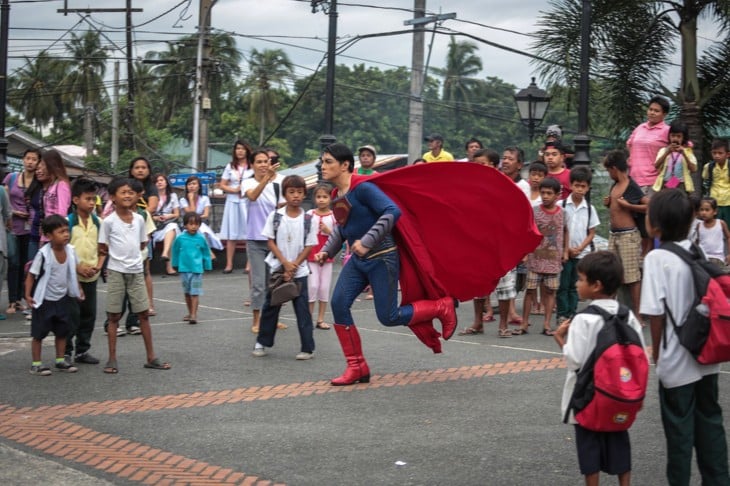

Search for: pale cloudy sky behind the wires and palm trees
xmin=9 ymin=0 xmax=714 ymax=95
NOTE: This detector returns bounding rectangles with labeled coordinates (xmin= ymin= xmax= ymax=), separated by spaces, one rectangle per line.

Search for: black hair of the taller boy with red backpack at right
xmin=648 ymin=189 xmax=694 ymax=241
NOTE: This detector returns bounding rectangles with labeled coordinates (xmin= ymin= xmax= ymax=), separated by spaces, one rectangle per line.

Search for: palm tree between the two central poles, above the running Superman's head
xmin=247 ymin=49 xmax=294 ymax=145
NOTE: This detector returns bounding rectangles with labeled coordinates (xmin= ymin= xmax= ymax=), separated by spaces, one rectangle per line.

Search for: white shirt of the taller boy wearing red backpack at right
xmin=640 ymin=240 xmax=720 ymax=388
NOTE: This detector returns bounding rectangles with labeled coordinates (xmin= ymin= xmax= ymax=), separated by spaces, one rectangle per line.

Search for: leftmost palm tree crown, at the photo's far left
xmin=8 ymin=51 xmax=64 ymax=138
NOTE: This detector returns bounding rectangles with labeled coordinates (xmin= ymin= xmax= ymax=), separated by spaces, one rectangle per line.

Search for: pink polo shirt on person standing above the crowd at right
xmin=626 ymin=121 xmax=669 ymax=186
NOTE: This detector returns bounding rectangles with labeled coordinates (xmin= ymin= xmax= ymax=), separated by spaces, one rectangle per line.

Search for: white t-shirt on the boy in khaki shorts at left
xmin=99 ymin=211 xmax=147 ymax=273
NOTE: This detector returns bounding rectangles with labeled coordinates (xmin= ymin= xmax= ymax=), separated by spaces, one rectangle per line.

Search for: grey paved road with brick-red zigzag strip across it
xmin=0 ymin=264 xmax=730 ymax=485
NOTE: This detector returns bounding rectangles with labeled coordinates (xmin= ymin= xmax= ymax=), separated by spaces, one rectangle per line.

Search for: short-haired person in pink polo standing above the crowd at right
xmin=626 ymin=96 xmax=669 ymax=192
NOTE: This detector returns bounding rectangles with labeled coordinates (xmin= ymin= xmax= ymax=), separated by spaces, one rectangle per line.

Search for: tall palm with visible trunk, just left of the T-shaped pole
xmin=64 ymin=30 xmax=108 ymax=154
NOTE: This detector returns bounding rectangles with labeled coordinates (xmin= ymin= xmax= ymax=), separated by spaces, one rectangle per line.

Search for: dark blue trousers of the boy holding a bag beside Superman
xmin=256 ymin=277 xmax=314 ymax=353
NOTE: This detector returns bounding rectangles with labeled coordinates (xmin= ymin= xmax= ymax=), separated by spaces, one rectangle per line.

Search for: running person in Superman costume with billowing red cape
xmin=315 ymin=143 xmax=542 ymax=385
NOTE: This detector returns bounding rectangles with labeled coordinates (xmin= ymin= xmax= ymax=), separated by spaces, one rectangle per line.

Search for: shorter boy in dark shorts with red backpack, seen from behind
xmin=554 ymin=251 xmax=649 ymax=485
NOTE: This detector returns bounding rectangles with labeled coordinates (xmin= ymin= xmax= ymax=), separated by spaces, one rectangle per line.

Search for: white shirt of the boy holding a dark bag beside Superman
xmin=261 ymin=207 xmax=319 ymax=278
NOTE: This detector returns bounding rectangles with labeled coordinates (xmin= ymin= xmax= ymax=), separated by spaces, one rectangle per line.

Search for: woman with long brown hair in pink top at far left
xmin=35 ymin=150 xmax=71 ymax=245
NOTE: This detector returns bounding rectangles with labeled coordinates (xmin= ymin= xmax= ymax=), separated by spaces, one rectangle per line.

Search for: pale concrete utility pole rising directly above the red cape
xmin=403 ymin=6 xmax=456 ymax=163
